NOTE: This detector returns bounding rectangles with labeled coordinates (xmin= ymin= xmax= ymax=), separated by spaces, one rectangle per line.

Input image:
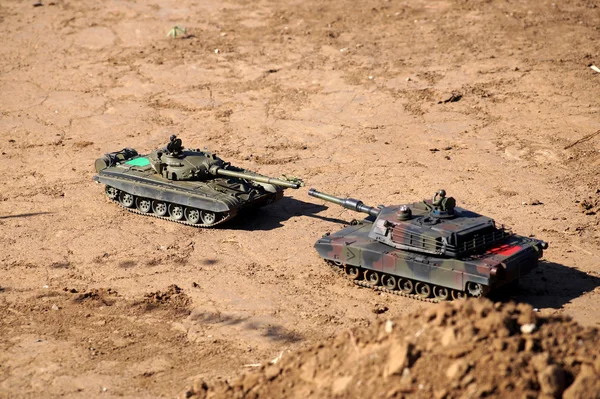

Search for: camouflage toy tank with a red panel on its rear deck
xmin=308 ymin=189 xmax=548 ymax=301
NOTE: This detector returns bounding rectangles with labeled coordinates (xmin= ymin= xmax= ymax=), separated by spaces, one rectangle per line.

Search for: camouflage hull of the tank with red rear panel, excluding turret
xmin=315 ymin=220 xmax=541 ymax=299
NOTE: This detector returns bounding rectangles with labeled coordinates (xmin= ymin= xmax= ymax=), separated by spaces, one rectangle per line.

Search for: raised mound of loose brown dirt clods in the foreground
xmin=182 ymin=300 xmax=600 ymax=399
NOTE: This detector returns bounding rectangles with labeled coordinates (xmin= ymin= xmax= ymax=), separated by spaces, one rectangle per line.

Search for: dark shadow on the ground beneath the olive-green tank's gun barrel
xmin=223 ymin=197 xmax=348 ymax=231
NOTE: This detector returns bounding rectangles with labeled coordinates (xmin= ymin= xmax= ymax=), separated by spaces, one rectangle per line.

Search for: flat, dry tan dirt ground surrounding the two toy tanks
xmin=0 ymin=0 xmax=600 ymax=398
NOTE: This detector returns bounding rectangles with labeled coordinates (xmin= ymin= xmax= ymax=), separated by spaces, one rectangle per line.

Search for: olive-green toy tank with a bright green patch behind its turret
xmin=94 ymin=136 xmax=302 ymax=227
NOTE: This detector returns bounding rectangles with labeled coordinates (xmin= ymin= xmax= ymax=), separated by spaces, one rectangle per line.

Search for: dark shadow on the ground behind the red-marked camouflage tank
xmin=491 ymin=261 xmax=600 ymax=309
